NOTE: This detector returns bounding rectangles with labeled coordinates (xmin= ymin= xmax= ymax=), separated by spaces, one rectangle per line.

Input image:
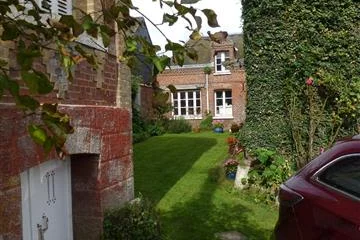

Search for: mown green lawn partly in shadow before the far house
xmin=134 ymin=132 xmax=277 ymax=240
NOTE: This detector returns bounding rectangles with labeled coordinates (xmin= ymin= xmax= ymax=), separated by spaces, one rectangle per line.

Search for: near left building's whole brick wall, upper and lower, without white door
xmin=0 ymin=42 xmax=134 ymax=240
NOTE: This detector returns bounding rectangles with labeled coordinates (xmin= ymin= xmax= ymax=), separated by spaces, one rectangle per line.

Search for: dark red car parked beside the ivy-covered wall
xmin=275 ymin=136 xmax=360 ymax=240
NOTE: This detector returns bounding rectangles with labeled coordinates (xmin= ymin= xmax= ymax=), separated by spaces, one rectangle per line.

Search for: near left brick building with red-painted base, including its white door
xmin=0 ymin=0 xmax=134 ymax=240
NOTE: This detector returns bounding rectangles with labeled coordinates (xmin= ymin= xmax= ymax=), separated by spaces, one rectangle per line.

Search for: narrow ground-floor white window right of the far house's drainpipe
xmin=215 ymin=90 xmax=232 ymax=117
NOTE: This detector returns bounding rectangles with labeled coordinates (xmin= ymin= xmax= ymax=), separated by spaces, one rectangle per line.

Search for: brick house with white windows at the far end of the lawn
xmin=157 ymin=35 xmax=246 ymax=128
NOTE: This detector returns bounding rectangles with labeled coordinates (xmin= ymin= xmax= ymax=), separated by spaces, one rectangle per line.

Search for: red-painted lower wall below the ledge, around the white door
xmin=0 ymin=104 xmax=133 ymax=239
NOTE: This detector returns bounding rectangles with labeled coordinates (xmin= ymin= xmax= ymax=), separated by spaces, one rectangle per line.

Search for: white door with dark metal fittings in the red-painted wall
xmin=21 ymin=159 xmax=73 ymax=240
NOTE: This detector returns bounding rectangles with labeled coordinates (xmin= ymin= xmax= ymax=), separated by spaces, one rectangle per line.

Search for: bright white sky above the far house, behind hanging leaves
xmin=132 ymin=0 xmax=242 ymax=52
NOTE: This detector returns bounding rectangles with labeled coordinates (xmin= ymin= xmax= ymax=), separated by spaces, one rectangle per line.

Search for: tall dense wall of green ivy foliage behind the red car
xmin=242 ymin=0 xmax=360 ymax=167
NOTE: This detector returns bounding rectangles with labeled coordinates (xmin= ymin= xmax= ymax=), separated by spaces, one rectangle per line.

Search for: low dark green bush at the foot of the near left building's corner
xmin=103 ymin=197 xmax=161 ymax=240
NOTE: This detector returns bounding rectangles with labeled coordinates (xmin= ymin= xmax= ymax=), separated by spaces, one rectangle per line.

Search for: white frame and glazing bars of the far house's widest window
xmin=171 ymin=89 xmax=202 ymax=119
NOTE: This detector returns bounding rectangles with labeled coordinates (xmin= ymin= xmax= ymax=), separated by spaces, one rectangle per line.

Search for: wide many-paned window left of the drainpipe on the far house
xmin=172 ymin=90 xmax=201 ymax=118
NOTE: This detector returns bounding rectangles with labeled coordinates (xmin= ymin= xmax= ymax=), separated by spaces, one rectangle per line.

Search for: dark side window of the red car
xmin=319 ymin=156 xmax=360 ymax=198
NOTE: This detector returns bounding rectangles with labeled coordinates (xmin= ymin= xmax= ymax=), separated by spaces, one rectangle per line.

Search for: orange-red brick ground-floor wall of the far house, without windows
xmin=157 ymin=67 xmax=246 ymax=128
